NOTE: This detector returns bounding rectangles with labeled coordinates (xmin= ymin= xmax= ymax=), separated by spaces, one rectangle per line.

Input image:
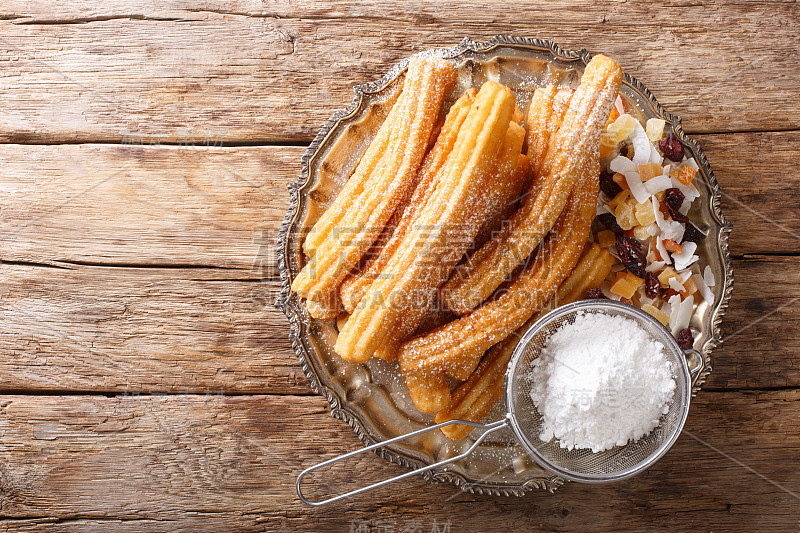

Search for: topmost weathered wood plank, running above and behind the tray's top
xmin=0 ymin=0 xmax=800 ymax=143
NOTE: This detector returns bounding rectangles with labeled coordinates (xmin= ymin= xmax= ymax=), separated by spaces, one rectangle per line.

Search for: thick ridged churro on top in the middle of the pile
xmin=335 ymin=82 xmax=520 ymax=362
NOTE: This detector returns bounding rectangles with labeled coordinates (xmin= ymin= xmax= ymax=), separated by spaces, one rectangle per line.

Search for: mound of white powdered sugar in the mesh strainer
xmin=527 ymin=313 xmax=676 ymax=452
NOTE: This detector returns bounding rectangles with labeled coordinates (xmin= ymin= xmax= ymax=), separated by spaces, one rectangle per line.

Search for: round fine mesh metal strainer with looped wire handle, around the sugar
xmin=296 ymin=300 xmax=703 ymax=506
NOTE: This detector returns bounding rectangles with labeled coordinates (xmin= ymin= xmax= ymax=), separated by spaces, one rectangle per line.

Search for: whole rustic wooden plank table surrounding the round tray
xmin=0 ymin=0 xmax=800 ymax=533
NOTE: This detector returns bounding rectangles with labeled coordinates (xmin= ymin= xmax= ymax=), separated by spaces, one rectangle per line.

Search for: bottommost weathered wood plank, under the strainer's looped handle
xmin=0 ymin=391 xmax=800 ymax=533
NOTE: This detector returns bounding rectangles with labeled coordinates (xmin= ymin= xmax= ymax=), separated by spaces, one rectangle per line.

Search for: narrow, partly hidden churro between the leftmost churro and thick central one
xmin=339 ymin=88 xmax=478 ymax=313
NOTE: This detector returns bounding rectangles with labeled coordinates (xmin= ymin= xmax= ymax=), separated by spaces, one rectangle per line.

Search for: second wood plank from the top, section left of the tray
xmin=0 ymin=145 xmax=294 ymax=270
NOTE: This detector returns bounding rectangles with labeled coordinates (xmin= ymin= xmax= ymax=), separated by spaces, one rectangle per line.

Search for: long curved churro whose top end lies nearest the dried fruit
xmin=442 ymin=55 xmax=622 ymax=314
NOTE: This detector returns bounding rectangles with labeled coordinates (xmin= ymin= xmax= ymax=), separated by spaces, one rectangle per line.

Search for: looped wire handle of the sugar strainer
xmin=295 ymin=418 xmax=508 ymax=507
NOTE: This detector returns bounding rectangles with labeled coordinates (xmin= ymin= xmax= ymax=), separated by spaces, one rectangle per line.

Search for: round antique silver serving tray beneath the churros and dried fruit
xmin=276 ymin=36 xmax=733 ymax=496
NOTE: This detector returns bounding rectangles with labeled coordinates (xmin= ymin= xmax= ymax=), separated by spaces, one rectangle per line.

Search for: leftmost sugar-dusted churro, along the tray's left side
xmin=292 ymin=57 xmax=455 ymax=302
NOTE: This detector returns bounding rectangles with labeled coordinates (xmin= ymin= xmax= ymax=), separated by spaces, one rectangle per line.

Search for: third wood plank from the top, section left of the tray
xmin=0 ymin=265 xmax=304 ymax=394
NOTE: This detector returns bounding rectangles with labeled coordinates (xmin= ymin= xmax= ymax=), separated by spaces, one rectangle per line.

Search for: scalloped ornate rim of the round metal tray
xmin=275 ymin=35 xmax=733 ymax=496
